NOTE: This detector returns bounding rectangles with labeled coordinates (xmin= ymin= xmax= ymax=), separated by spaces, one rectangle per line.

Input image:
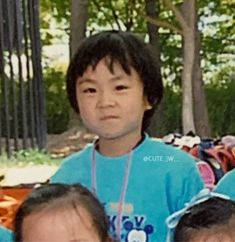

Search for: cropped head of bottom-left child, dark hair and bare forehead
xmin=14 ymin=184 xmax=109 ymax=242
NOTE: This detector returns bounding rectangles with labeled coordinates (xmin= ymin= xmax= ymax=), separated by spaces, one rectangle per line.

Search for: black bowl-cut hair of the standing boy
xmin=66 ymin=30 xmax=163 ymax=131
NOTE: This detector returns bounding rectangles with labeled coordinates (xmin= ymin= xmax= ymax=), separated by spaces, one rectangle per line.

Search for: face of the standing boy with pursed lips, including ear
xmin=76 ymin=59 xmax=151 ymax=139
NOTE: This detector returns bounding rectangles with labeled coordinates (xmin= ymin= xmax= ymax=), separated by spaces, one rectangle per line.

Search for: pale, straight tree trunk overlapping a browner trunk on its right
xmin=182 ymin=0 xmax=196 ymax=134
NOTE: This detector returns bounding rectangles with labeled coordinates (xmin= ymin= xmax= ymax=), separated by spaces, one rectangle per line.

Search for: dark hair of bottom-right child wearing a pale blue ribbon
xmin=174 ymin=197 xmax=235 ymax=242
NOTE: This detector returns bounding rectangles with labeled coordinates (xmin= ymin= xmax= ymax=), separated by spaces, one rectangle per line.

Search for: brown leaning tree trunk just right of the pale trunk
xmin=193 ymin=31 xmax=211 ymax=137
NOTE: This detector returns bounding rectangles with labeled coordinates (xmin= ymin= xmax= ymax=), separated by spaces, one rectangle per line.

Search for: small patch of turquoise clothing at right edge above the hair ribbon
xmin=215 ymin=169 xmax=235 ymax=200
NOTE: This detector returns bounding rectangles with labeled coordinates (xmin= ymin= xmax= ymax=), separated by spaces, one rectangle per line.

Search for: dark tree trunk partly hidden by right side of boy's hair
xmin=145 ymin=0 xmax=163 ymax=136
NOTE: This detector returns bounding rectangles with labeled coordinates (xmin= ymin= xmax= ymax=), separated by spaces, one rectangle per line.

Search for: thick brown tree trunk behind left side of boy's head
xmin=69 ymin=0 xmax=88 ymax=130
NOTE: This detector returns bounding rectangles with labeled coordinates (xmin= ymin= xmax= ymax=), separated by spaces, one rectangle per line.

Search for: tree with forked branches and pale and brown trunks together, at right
xmin=145 ymin=0 xmax=210 ymax=136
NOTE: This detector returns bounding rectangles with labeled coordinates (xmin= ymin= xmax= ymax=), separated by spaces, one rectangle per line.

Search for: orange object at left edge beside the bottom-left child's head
xmin=0 ymin=185 xmax=34 ymax=230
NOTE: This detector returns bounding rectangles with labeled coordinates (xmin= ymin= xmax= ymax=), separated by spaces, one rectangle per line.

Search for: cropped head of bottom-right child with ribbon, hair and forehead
xmin=174 ymin=197 xmax=235 ymax=242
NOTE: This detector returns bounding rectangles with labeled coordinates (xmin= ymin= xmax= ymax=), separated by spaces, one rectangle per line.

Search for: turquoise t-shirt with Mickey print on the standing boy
xmin=51 ymin=135 xmax=203 ymax=242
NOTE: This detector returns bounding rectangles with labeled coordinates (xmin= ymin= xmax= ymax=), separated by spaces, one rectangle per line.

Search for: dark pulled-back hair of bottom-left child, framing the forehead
xmin=14 ymin=184 xmax=109 ymax=242
